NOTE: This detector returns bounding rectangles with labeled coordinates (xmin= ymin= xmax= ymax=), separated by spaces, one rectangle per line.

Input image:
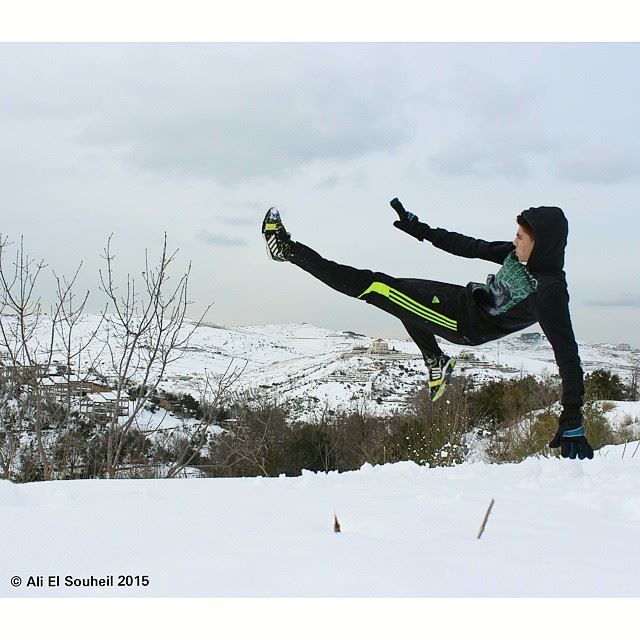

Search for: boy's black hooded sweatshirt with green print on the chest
xmin=419 ymin=207 xmax=584 ymax=427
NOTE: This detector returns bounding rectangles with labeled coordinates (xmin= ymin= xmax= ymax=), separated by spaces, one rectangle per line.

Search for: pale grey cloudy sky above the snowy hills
xmin=0 ymin=43 xmax=640 ymax=346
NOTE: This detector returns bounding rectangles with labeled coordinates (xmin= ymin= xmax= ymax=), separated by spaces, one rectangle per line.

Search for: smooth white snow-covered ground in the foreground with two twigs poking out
xmin=0 ymin=443 xmax=640 ymax=597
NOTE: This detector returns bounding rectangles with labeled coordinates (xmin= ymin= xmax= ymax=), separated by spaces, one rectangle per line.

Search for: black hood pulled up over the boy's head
xmin=521 ymin=207 xmax=569 ymax=273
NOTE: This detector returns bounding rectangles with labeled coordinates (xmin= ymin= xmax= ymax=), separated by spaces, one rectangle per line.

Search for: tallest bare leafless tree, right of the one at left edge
xmin=100 ymin=233 xmax=209 ymax=477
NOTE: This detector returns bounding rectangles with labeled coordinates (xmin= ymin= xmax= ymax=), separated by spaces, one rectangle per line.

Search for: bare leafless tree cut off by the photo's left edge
xmin=0 ymin=237 xmax=105 ymax=479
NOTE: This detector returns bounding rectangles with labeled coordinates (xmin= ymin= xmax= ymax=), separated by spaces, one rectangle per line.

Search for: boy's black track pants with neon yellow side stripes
xmin=290 ymin=242 xmax=467 ymax=360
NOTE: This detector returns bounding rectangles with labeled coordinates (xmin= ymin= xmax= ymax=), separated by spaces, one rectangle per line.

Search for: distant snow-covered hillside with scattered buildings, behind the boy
xmin=3 ymin=315 xmax=640 ymax=418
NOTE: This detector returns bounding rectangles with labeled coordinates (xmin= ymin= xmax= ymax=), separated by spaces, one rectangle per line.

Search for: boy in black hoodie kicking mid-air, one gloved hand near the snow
xmin=262 ymin=198 xmax=593 ymax=460
